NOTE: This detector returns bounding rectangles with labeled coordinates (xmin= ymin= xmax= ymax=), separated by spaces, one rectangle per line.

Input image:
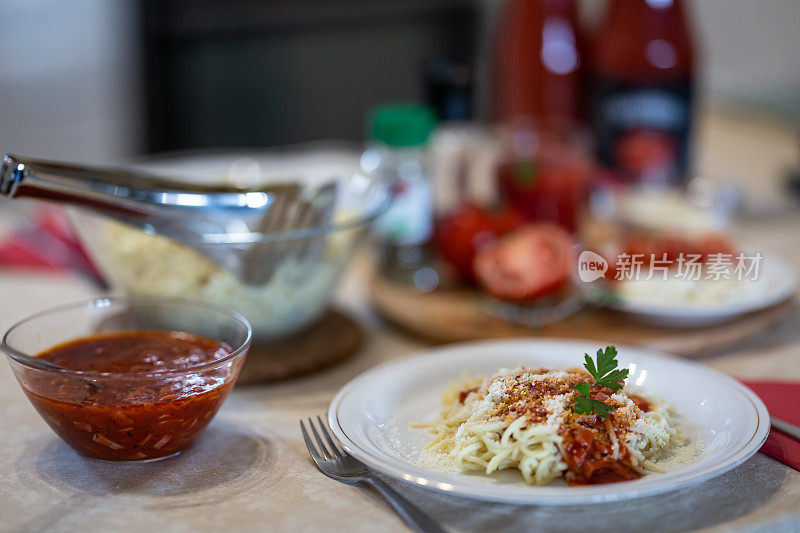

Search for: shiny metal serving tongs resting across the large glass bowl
xmin=0 ymin=155 xmax=336 ymax=285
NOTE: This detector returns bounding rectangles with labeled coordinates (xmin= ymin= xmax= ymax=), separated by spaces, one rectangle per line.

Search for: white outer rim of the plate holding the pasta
xmin=327 ymin=338 xmax=770 ymax=505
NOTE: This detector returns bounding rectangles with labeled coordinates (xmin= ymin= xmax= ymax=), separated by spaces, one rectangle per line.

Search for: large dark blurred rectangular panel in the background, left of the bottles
xmin=138 ymin=0 xmax=479 ymax=151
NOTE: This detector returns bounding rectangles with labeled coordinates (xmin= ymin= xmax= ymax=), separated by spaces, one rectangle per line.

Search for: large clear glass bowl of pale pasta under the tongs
xmin=73 ymin=145 xmax=390 ymax=342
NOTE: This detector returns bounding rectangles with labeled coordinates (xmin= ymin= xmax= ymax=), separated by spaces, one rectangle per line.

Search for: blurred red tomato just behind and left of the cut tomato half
xmin=436 ymin=203 xmax=522 ymax=283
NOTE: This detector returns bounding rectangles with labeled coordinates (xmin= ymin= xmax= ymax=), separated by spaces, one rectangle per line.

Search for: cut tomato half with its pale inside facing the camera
xmin=473 ymin=224 xmax=573 ymax=302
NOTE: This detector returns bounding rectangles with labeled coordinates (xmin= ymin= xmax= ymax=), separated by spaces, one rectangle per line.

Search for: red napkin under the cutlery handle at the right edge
xmin=742 ymin=381 xmax=800 ymax=471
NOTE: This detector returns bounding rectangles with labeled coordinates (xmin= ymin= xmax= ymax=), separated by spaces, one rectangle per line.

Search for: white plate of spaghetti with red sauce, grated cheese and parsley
xmin=328 ymin=340 xmax=769 ymax=504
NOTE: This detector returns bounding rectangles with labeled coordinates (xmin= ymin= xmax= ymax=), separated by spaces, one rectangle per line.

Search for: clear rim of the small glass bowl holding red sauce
xmin=0 ymin=296 xmax=253 ymax=380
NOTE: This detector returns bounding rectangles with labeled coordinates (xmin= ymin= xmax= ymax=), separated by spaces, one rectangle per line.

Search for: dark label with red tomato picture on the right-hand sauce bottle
xmin=593 ymin=80 xmax=692 ymax=181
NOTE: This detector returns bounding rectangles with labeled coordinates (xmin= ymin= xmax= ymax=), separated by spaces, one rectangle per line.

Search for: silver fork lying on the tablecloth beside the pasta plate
xmin=300 ymin=416 xmax=445 ymax=533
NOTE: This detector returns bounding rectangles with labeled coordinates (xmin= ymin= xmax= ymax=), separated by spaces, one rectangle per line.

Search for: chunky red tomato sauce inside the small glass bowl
xmin=25 ymin=331 xmax=234 ymax=461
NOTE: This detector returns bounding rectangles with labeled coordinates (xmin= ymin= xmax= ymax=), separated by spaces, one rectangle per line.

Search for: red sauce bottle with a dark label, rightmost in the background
xmin=591 ymin=0 xmax=695 ymax=184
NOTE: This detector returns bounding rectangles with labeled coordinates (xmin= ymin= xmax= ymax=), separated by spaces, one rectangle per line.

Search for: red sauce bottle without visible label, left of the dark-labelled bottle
xmin=494 ymin=0 xmax=581 ymax=126
